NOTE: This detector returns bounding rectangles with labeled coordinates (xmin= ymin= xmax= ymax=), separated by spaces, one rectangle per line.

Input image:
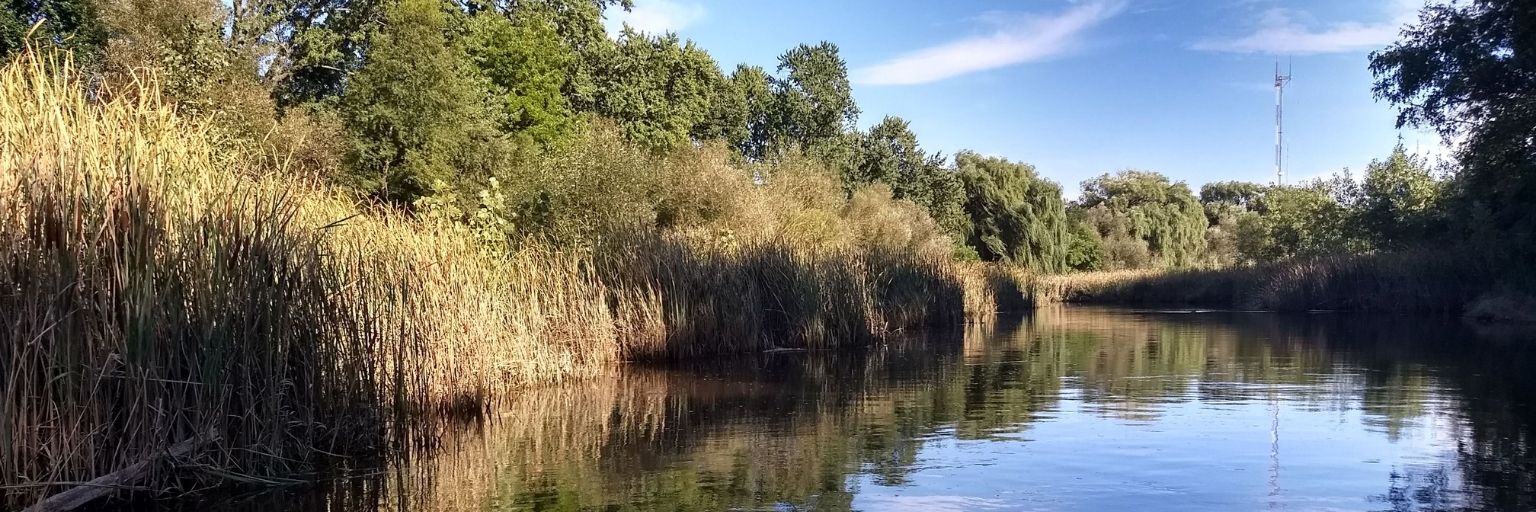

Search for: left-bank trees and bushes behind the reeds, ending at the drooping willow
xmin=0 ymin=0 xmax=1068 ymax=271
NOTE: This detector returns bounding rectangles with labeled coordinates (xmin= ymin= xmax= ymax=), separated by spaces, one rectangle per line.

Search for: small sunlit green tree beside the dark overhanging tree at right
xmin=1359 ymin=143 xmax=1445 ymax=249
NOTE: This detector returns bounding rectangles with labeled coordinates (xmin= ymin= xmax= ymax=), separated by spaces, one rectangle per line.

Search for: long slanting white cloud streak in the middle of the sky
xmin=854 ymin=0 xmax=1124 ymax=85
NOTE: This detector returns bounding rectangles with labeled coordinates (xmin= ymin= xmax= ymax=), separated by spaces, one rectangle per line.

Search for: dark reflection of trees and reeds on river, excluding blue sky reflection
xmin=185 ymin=304 xmax=1536 ymax=512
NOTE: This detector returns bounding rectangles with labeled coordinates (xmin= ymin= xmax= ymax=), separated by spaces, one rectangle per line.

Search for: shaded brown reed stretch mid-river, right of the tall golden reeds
xmin=594 ymin=235 xmax=965 ymax=360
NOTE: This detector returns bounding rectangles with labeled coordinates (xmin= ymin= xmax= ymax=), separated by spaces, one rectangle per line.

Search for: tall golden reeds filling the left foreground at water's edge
xmin=0 ymin=50 xmax=617 ymax=507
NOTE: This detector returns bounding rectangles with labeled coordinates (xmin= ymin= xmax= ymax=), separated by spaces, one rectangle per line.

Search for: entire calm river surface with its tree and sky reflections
xmin=204 ymin=304 xmax=1536 ymax=512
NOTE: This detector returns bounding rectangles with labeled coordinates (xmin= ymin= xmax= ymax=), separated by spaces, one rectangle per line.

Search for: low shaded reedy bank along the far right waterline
xmin=1031 ymin=249 xmax=1519 ymax=320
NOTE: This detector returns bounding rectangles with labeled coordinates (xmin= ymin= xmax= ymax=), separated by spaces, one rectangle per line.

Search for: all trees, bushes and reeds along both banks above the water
xmin=0 ymin=0 xmax=1536 ymax=509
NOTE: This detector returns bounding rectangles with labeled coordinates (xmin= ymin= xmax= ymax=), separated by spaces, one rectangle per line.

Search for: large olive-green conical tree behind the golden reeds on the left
xmin=343 ymin=0 xmax=490 ymax=204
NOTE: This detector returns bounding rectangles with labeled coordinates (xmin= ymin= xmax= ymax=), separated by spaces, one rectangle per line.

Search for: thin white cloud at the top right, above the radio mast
xmin=1193 ymin=0 xmax=1422 ymax=55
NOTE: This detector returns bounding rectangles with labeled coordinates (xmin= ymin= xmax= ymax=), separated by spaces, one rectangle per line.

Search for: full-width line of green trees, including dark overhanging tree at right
xmin=0 ymin=0 xmax=1536 ymax=272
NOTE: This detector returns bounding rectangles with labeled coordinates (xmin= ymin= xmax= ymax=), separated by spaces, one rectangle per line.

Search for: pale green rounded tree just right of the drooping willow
xmin=1080 ymin=171 xmax=1207 ymax=268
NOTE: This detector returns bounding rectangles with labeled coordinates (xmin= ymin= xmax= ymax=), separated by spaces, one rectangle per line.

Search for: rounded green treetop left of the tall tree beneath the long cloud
xmin=596 ymin=28 xmax=725 ymax=149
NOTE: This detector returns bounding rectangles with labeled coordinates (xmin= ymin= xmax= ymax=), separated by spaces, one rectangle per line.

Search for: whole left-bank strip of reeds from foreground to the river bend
xmin=0 ymin=55 xmax=1025 ymax=509
